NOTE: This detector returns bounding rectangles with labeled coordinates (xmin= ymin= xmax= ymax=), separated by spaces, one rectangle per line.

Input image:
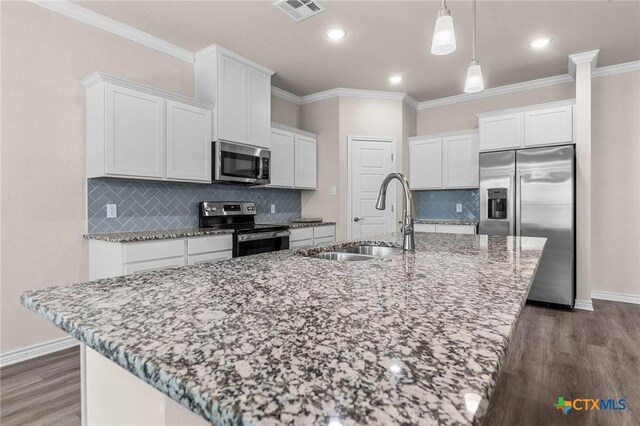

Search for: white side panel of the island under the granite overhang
xmin=82 ymin=347 xmax=210 ymax=426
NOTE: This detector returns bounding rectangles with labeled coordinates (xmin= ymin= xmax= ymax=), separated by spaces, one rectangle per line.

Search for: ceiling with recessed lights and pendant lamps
xmin=79 ymin=0 xmax=640 ymax=101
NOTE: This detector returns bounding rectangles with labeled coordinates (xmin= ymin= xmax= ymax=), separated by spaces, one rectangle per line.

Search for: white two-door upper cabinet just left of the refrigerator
xmin=409 ymin=130 xmax=479 ymax=189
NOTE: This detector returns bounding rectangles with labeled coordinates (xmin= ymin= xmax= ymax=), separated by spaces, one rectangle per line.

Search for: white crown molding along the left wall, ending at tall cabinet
xmin=29 ymin=0 xmax=195 ymax=64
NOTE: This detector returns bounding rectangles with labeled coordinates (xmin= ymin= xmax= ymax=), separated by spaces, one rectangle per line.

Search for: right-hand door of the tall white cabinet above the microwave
xmin=246 ymin=67 xmax=271 ymax=148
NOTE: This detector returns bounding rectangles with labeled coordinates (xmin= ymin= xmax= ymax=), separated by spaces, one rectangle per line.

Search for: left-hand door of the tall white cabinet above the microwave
xmin=216 ymin=55 xmax=247 ymax=143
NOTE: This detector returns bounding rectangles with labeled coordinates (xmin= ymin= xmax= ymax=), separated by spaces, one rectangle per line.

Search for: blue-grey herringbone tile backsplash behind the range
xmin=87 ymin=178 xmax=301 ymax=233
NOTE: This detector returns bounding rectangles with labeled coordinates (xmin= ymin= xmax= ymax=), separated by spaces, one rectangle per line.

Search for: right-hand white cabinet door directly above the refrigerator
xmin=524 ymin=105 xmax=573 ymax=146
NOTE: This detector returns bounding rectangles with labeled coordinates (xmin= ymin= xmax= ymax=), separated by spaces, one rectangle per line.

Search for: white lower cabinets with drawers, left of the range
xmin=89 ymin=234 xmax=233 ymax=280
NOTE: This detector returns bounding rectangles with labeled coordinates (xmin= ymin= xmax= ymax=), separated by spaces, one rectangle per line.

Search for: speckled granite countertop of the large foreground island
xmin=21 ymin=233 xmax=546 ymax=426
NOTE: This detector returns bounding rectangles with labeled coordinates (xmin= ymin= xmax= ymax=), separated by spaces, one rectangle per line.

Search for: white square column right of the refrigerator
xmin=569 ymin=50 xmax=599 ymax=310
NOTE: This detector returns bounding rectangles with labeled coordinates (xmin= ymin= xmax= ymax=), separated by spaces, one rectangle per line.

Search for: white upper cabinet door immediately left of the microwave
xmin=167 ymin=101 xmax=211 ymax=182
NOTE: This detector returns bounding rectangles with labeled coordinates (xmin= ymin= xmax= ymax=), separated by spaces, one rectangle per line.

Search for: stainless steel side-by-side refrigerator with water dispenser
xmin=479 ymin=145 xmax=575 ymax=307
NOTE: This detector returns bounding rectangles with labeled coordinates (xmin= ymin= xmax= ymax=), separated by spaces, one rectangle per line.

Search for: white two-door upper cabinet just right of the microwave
xmin=269 ymin=123 xmax=318 ymax=189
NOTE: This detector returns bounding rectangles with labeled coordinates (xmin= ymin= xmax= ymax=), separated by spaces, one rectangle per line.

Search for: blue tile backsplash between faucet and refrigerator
xmin=416 ymin=189 xmax=480 ymax=220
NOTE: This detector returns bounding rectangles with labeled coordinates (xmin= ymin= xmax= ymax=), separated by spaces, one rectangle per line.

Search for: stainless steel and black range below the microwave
xmin=199 ymin=201 xmax=291 ymax=257
